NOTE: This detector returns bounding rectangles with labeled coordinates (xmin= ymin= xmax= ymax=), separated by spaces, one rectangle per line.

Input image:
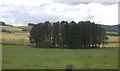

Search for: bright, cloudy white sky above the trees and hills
xmin=0 ymin=0 xmax=118 ymax=26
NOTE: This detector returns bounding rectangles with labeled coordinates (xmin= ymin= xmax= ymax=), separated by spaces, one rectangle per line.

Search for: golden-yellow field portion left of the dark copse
xmin=2 ymin=33 xmax=29 ymax=45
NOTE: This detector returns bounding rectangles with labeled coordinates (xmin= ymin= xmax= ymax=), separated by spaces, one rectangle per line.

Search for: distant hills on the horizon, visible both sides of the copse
xmin=0 ymin=21 xmax=120 ymax=35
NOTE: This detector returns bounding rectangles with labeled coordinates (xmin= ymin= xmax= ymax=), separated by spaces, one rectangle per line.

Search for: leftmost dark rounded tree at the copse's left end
xmin=29 ymin=23 xmax=46 ymax=47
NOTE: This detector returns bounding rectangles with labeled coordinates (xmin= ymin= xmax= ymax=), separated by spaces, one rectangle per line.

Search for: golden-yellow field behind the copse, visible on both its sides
xmin=1 ymin=32 xmax=119 ymax=47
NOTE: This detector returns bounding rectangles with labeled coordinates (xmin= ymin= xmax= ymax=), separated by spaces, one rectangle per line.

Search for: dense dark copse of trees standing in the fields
xmin=29 ymin=21 xmax=108 ymax=49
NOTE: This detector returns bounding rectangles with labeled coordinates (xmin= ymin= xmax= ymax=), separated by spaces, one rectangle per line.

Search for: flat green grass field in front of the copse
xmin=2 ymin=45 xmax=118 ymax=69
